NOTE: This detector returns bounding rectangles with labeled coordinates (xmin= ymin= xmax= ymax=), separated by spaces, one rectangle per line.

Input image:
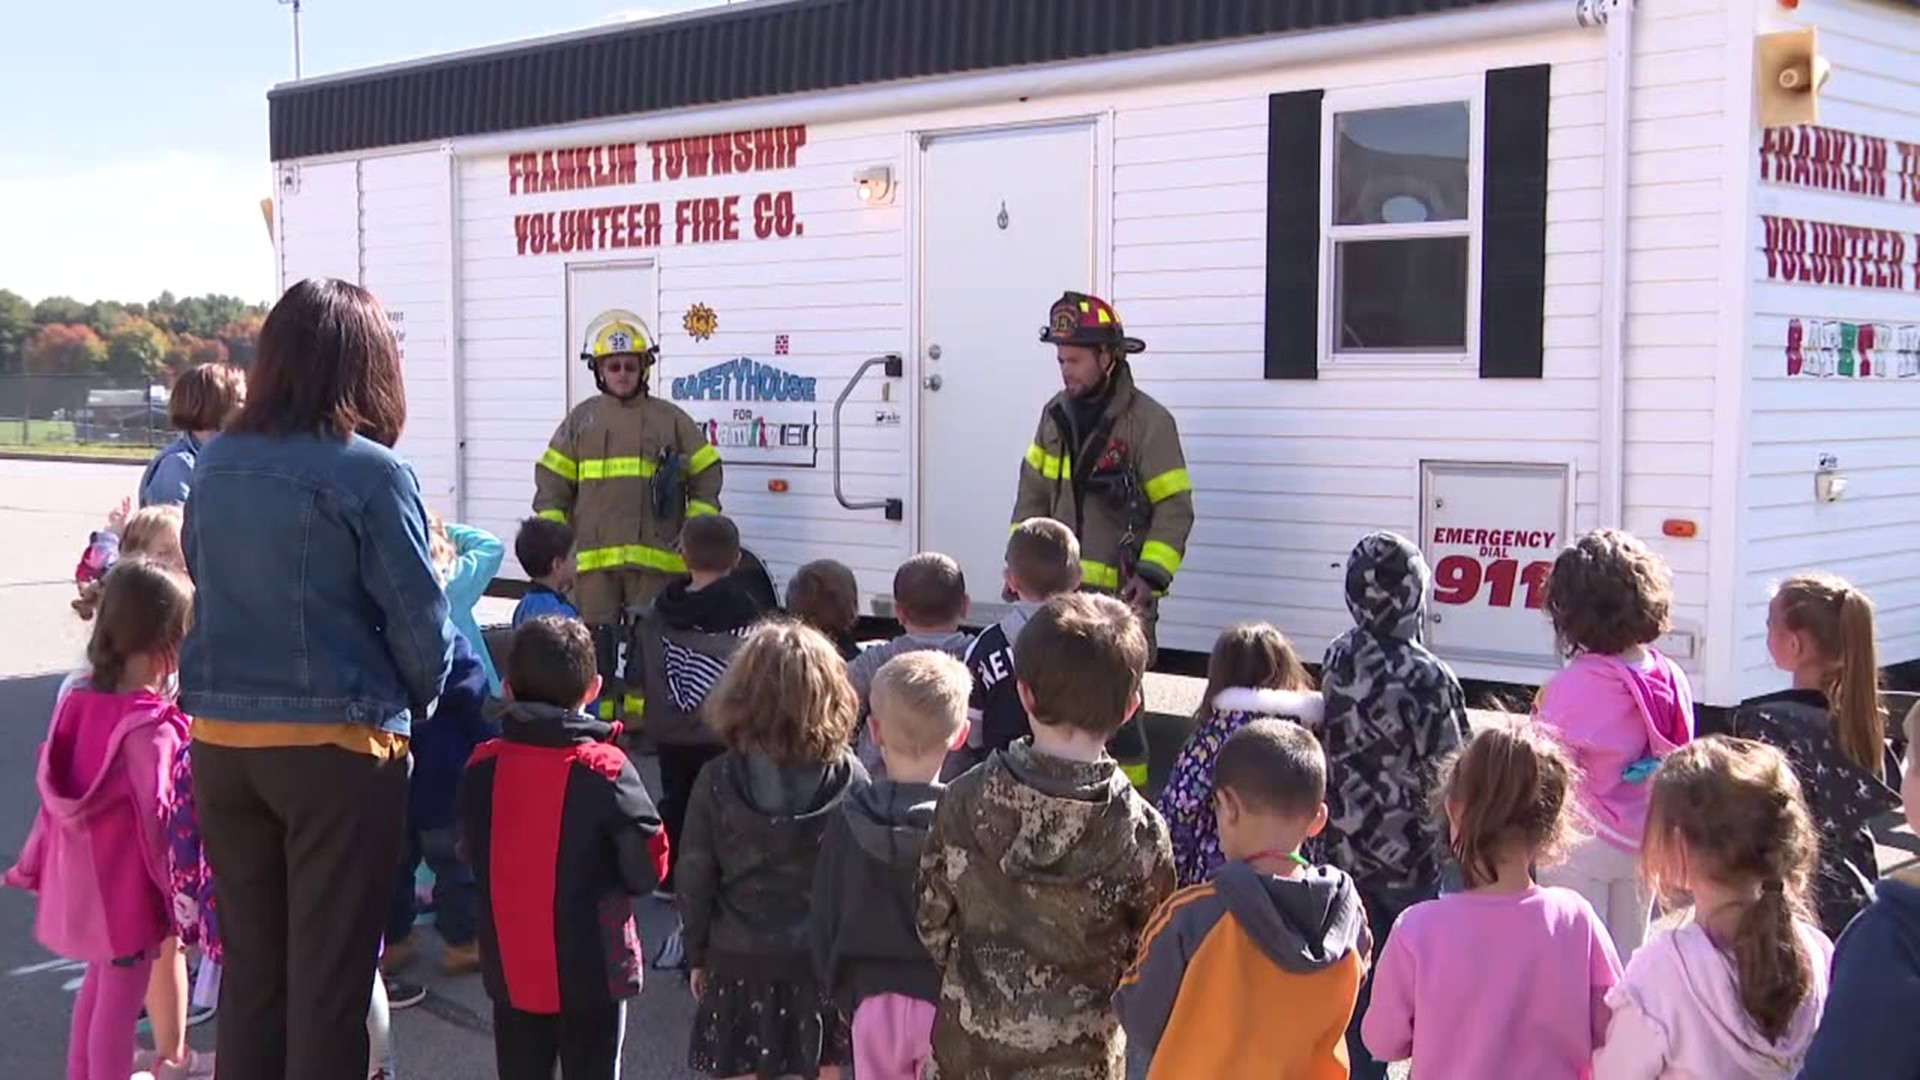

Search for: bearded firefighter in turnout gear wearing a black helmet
xmin=1014 ymin=292 xmax=1194 ymax=786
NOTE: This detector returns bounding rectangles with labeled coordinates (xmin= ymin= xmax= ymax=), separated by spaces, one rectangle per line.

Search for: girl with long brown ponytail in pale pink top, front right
xmin=1594 ymin=736 xmax=1834 ymax=1080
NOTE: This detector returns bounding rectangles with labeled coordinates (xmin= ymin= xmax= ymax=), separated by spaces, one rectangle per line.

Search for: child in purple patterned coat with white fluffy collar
xmin=1160 ymin=623 xmax=1321 ymax=886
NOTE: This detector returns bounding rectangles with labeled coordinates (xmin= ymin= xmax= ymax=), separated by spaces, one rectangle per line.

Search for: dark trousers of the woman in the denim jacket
xmin=194 ymin=742 xmax=407 ymax=1080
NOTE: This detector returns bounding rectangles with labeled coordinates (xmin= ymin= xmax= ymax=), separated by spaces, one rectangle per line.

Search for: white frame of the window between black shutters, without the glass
xmin=1315 ymin=79 xmax=1486 ymax=373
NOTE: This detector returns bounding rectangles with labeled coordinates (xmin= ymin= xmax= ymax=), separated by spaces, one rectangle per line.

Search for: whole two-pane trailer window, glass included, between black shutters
xmin=1321 ymin=96 xmax=1478 ymax=363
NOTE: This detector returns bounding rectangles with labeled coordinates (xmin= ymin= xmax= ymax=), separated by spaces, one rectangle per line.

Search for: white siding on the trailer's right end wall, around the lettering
xmin=1738 ymin=0 xmax=1920 ymax=696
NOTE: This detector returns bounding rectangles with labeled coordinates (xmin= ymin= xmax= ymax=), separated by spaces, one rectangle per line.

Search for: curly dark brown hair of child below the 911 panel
xmin=1546 ymin=528 xmax=1672 ymax=655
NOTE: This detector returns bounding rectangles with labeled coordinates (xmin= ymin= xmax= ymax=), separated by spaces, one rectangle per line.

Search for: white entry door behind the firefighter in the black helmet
xmin=916 ymin=123 xmax=1094 ymax=617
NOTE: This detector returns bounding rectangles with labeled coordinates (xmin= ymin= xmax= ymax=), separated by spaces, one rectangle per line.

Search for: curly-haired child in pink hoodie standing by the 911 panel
xmin=1536 ymin=528 xmax=1693 ymax=961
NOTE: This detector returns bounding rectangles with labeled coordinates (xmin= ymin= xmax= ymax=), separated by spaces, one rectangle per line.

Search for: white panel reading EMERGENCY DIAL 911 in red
xmin=1421 ymin=461 xmax=1572 ymax=667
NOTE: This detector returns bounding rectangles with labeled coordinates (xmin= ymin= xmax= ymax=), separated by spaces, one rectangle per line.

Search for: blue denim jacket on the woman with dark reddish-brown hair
xmin=180 ymin=434 xmax=455 ymax=734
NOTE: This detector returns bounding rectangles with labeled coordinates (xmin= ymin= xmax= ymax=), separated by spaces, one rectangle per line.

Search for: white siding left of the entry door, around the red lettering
xmin=461 ymin=131 xmax=917 ymax=596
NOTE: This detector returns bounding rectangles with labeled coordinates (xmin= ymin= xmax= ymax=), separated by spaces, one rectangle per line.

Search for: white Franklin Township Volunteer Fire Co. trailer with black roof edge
xmin=269 ymin=0 xmax=1920 ymax=703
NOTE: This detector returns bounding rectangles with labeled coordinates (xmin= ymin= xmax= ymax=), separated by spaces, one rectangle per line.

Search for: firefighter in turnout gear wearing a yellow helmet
xmin=534 ymin=311 xmax=722 ymax=717
